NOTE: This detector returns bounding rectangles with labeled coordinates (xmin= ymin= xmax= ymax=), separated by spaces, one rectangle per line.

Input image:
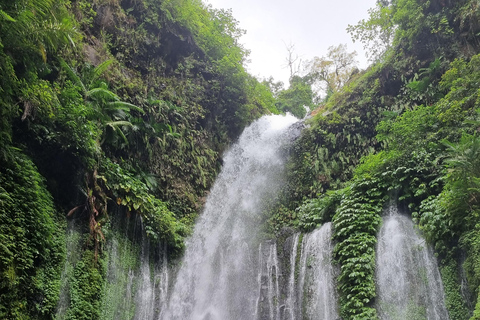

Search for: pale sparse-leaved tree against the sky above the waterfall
xmin=306 ymin=44 xmax=357 ymax=98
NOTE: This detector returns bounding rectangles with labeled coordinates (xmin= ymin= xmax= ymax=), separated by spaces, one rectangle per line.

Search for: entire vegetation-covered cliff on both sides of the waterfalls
xmin=0 ymin=0 xmax=480 ymax=319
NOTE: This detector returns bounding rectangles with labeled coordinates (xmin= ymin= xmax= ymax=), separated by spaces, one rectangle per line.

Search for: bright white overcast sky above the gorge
xmin=204 ymin=0 xmax=376 ymax=87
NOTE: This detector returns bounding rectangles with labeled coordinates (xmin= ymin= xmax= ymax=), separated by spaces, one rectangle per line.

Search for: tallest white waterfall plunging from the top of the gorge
xmin=165 ymin=116 xmax=297 ymax=320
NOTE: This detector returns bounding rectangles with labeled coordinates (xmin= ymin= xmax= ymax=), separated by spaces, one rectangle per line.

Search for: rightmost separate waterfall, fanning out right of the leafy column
xmin=376 ymin=206 xmax=449 ymax=320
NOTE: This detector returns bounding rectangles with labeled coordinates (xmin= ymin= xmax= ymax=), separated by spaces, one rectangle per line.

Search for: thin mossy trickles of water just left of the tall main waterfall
xmin=101 ymin=215 xmax=169 ymax=320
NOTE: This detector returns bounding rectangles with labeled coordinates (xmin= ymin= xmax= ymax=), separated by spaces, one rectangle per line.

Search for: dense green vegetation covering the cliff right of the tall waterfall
xmin=278 ymin=0 xmax=480 ymax=319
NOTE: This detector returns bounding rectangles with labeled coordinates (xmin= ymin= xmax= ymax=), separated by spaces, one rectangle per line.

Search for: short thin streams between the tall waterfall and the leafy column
xmin=253 ymin=223 xmax=338 ymax=320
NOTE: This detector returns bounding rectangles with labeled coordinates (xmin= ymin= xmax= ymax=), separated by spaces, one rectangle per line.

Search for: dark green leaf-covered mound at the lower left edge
xmin=0 ymin=146 xmax=65 ymax=319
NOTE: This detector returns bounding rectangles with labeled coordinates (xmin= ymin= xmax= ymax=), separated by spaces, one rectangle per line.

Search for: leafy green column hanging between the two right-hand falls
xmin=332 ymin=180 xmax=384 ymax=319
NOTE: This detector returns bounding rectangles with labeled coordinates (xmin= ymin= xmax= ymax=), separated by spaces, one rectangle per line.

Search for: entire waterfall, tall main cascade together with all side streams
xmin=56 ymin=116 xmax=454 ymax=320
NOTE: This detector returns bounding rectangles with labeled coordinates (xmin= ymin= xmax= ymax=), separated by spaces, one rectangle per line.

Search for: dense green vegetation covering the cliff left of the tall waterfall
xmin=0 ymin=0 xmax=277 ymax=319
